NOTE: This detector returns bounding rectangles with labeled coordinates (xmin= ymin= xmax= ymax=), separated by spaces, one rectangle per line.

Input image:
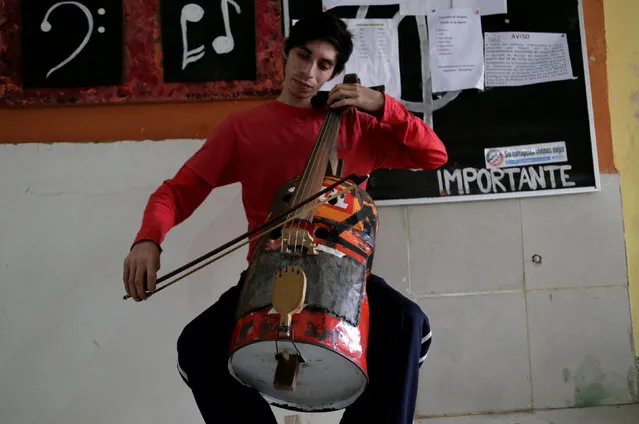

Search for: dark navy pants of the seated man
xmin=177 ymin=275 xmax=431 ymax=424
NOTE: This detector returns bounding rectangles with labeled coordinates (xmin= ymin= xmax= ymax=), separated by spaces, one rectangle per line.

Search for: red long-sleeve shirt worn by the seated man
xmin=134 ymin=95 xmax=447 ymax=258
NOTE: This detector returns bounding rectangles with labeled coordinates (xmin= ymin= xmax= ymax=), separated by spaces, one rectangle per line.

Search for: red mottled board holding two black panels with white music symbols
xmin=0 ymin=0 xmax=283 ymax=106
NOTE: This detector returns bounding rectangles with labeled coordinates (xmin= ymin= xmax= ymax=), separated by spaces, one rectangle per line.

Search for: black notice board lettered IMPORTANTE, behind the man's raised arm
xmin=283 ymin=0 xmax=600 ymax=205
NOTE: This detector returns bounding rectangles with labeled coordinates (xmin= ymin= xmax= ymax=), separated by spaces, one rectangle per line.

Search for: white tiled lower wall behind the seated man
xmin=0 ymin=140 xmax=637 ymax=424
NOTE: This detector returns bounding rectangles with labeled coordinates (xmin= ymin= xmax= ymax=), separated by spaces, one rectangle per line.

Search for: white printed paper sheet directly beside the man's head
xmin=321 ymin=19 xmax=401 ymax=99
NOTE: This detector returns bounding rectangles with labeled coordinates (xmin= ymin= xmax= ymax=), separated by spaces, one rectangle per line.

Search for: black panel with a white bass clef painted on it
xmin=21 ymin=0 xmax=123 ymax=88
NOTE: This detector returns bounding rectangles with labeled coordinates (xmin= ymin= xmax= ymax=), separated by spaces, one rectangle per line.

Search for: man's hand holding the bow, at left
xmin=124 ymin=241 xmax=160 ymax=302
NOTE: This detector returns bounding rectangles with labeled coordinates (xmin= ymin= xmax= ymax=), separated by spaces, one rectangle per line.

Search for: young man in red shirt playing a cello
xmin=124 ymin=14 xmax=447 ymax=424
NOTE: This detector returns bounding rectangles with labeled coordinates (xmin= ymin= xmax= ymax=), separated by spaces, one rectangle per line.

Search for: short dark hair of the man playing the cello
xmin=284 ymin=13 xmax=353 ymax=75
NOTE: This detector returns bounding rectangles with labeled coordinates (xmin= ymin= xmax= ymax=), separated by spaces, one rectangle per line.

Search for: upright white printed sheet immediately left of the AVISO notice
xmin=428 ymin=9 xmax=484 ymax=93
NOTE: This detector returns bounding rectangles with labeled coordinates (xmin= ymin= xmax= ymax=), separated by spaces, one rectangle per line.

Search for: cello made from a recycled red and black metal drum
xmin=229 ymin=74 xmax=378 ymax=411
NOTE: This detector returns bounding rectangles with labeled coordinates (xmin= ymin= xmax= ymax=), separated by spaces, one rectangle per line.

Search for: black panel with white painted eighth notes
xmin=160 ymin=0 xmax=257 ymax=82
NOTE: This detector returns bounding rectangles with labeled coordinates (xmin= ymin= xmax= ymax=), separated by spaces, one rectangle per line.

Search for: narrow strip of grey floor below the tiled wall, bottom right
xmin=416 ymin=405 xmax=639 ymax=424
